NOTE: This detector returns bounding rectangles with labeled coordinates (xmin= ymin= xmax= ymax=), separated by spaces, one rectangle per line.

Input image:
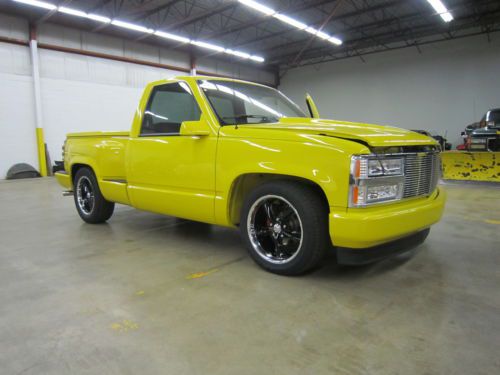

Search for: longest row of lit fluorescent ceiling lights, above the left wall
xmin=12 ymin=0 xmax=266 ymax=63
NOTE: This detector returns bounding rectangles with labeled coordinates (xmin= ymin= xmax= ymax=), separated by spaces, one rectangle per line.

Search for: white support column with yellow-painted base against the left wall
xmin=30 ymin=25 xmax=47 ymax=177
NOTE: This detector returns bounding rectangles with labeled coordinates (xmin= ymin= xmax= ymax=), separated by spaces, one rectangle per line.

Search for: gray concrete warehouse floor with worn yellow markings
xmin=0 ymin=178 xmax=500 ymax=375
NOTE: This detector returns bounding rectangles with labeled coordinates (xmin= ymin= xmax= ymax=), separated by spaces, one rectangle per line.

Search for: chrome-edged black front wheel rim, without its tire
xmin=247 ymin=195 xmax=303 ymax=264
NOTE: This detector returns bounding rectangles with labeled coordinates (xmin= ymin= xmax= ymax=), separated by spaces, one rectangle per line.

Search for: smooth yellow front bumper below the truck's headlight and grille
xmin=329 ymin=188 xmax=446 ymax=251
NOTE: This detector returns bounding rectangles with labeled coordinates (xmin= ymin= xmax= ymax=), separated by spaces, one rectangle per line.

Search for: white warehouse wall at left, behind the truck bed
xmin=0 ymin=15 xmax=275 ymax=179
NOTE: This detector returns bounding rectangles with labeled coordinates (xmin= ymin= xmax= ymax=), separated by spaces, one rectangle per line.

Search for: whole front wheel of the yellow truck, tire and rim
xmin=240 ymin=180 xmax=331 ymax=276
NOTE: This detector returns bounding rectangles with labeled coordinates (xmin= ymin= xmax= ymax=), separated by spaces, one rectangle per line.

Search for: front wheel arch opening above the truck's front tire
xmin=228 ymin=173 xmax=330 ymax=225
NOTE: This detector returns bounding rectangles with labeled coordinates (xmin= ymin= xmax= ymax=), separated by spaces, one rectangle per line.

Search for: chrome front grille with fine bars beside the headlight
xmin=403 ymin=152 xmax=441 ymax=198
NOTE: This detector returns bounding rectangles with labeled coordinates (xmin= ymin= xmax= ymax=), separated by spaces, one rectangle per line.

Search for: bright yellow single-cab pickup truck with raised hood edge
xmin=56 ymin=76 xmax=445 ymax=275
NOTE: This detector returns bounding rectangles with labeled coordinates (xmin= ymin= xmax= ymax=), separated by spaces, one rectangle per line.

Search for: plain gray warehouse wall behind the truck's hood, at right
xmin=280 ymin=33 xmax=500 ymax=147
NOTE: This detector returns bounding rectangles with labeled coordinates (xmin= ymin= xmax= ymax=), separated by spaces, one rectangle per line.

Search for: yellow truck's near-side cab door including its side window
xmin=127 ymin=82 xmax=217 ymax=223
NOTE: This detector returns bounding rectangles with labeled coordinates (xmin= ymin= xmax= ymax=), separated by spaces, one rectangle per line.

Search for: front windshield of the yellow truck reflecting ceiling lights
xmin=199 ymin=79 xmax=307 ymax=125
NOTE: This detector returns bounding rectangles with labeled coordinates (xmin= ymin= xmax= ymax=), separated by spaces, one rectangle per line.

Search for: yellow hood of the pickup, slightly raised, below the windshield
xmin=235 ymin=117 xmax=437 ymax=147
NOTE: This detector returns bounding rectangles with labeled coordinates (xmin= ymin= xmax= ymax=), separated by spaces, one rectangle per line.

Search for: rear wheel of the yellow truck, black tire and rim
xmin=73 ymin=167 xmax=115 ymax=224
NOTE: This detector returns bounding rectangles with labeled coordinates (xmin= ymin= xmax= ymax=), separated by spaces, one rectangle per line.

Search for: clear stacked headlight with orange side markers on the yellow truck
xmin=349 ymin=155 xmax=404 ymax=207
